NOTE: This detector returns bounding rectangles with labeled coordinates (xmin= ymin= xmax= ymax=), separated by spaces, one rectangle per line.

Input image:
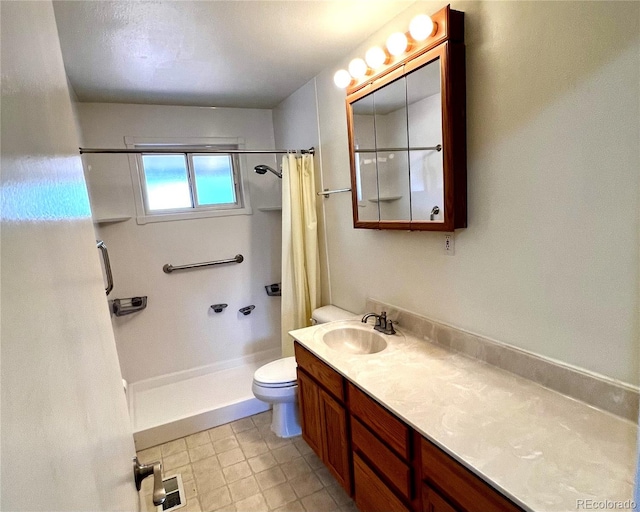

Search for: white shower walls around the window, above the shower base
xmin=78 ymin=103 xmax=281 ymax=382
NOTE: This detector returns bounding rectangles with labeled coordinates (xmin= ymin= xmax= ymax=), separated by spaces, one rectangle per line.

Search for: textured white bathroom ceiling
xmin=54 ymin=0 xmax=413 ymax=108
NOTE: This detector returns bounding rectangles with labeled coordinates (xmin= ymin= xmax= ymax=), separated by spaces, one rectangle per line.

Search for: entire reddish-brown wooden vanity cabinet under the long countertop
xmin=295 ymin=342 xmax=522 ymax=512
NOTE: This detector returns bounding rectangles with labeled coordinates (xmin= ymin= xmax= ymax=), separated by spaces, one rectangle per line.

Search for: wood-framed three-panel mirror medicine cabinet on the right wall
xmin=346 ymin=6 xmax=467 ymax=231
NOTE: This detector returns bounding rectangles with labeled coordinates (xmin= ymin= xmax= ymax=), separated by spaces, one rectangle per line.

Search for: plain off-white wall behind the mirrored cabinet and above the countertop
xmin=292 ymin=0 xmax=640 ymax=385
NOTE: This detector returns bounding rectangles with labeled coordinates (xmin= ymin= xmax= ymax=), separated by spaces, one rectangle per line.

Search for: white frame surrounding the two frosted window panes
xmin=125 ymin=137 xmax=253 ymax=224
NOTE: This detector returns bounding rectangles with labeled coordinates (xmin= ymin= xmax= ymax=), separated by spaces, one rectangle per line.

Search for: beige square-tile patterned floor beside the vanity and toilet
xmin=138 ymin=411 xmax=357 ymax=512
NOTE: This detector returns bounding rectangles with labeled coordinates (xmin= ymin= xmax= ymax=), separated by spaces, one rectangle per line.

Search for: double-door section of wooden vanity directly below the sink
xmin=295 ymin=343 xmax=352 ymax=495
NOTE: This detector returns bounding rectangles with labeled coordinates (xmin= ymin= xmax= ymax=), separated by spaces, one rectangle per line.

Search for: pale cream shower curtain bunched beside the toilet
xmin=281 ymin=154 xmax=320 ymax=357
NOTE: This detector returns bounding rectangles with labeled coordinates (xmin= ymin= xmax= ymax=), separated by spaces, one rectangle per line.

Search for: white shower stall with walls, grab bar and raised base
xmin=77 ymin=104 xmax=308 ymax=450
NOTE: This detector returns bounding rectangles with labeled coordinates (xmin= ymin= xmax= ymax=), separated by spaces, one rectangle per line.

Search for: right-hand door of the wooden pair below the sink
xmin=320 ymin=390 xmax=351 ymax=495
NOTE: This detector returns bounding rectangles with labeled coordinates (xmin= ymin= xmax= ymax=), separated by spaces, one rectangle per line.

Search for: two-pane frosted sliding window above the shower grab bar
xmin=129 ymin=144 xmax=251 ymax=224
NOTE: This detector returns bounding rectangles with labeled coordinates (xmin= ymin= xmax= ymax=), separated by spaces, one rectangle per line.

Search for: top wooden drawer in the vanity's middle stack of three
xmin=349 ymin=383 xmax=411 ymax=460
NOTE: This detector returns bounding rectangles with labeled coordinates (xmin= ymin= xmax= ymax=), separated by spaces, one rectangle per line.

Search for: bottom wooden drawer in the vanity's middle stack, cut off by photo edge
xmin=353 ymin=455 xmax=409 ymax=512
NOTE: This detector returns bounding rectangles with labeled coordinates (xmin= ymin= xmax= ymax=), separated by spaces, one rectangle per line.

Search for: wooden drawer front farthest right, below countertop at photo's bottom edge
xmin=421 ymin=439 xmax=522 ymax=512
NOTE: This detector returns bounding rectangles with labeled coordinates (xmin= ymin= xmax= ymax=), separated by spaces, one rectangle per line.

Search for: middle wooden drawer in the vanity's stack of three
xmin=351 ymin=418 xmax=413 ymax=500
